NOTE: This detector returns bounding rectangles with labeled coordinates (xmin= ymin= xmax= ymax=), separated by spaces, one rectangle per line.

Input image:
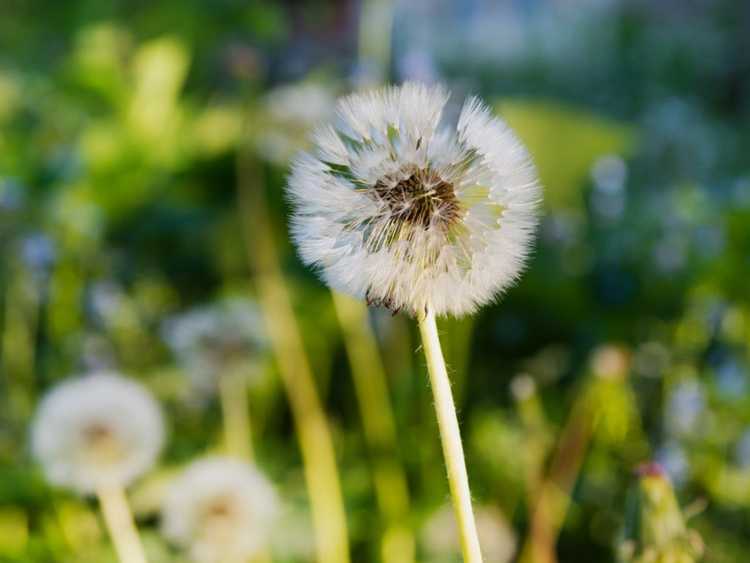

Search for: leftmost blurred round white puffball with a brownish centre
xmin=31 ymin=372 xmax=164 ymax=494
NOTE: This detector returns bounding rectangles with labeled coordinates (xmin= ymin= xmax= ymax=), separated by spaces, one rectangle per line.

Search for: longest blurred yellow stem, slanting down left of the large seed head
xmin=237 ymin=147 xmax=349 ymax=563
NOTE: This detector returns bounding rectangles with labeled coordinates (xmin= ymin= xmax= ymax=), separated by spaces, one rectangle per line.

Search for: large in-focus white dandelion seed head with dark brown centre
xmin=288 ymin=83 xmax=541 ymax=315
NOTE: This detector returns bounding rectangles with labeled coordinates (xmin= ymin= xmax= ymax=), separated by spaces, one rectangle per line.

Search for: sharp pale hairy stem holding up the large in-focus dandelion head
xmin=418 ymin=308 xmax=482 ymax=563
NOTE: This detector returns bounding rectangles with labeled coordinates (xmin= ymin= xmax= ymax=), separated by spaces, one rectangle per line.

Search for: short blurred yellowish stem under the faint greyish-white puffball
xmin=219 ymin=374 xmax=255 ymax=461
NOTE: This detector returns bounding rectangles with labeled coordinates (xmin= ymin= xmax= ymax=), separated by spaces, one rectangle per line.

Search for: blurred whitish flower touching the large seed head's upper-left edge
xmin=257 ymin=82 xmax=336 ymax=165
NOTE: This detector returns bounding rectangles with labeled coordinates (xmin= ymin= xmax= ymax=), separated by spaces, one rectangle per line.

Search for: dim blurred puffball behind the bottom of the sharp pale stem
xmin=422 ymin=506 xmax=516 ymax=563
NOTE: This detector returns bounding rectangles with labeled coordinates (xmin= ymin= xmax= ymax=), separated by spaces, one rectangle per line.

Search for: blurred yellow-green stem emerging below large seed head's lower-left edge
xmin=332 ymin=291 xmax=415 ymax=563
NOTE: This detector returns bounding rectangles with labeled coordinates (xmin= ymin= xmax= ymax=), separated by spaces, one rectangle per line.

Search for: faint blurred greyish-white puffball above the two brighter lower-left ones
xmin=163 ymin=297 xmax=266 ymax=394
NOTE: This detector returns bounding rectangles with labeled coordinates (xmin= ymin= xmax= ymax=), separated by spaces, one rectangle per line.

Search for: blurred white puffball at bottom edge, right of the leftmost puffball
xmin=162 ymin=457 xmax=278 ymax=563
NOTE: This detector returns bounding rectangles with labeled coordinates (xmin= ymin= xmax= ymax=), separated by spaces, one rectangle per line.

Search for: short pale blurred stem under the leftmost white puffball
xmin=97 ymin=486 xmax=146 ymax=563
